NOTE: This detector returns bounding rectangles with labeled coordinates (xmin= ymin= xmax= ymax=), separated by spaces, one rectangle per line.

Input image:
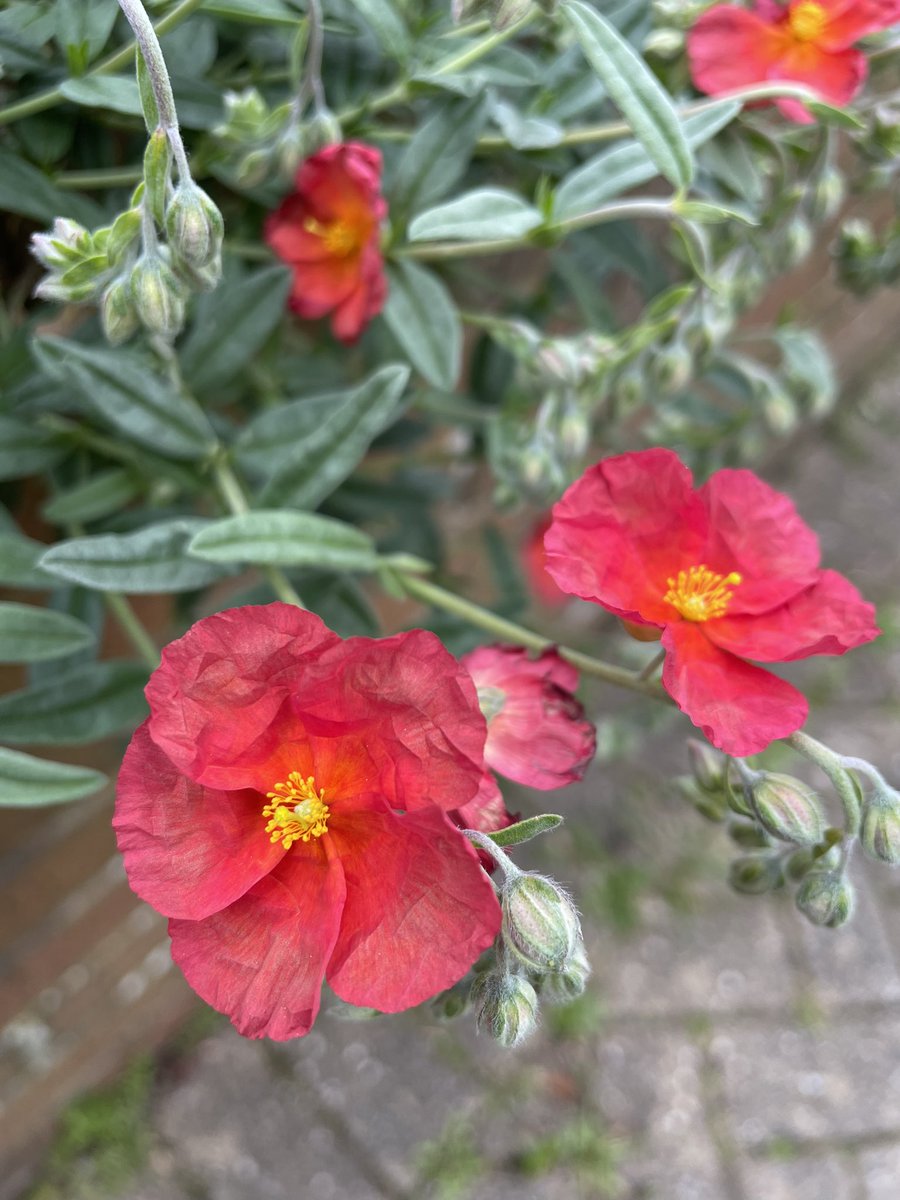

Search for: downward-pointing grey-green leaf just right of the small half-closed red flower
xmin=384 ymin=262 xmax=462 ymax=391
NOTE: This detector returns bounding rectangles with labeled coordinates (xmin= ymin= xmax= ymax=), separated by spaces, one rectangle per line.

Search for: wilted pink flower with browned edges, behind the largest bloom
xmin=461 ymin=646 xmax=596 ymax=791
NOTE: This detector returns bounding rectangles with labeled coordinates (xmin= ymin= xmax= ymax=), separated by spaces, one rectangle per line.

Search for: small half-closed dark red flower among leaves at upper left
xmin=265 ymin=142 xmax=388 ymax=342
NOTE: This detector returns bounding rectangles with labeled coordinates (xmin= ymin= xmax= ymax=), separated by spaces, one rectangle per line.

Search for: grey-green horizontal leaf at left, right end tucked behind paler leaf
xmin=41 ymin=517 xmax=236 ymax=593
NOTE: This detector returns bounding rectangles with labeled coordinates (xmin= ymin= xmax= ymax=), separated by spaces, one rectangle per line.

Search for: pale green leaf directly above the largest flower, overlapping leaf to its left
xmin=187 ymin=509 xmax=377 ymax=571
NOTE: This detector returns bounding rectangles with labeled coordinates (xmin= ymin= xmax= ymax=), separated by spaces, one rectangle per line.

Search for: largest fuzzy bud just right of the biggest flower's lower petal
xmin=502 ymin=874 xmax=581 ymax=972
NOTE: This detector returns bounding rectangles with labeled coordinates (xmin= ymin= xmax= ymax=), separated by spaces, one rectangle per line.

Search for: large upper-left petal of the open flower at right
xmin=544 ymin=450 xmax=707 ymax=625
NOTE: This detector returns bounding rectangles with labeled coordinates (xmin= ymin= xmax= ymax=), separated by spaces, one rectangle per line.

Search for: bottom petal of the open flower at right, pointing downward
xmin=662 ymin=620 xmax=809 ymax=757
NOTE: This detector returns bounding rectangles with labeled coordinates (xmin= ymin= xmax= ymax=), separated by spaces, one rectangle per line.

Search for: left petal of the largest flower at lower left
xmin=113 ymin=721 xmax=284 ymax=920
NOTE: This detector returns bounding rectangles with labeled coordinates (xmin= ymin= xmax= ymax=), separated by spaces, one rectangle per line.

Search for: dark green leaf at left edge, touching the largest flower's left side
xmin=0 ymin=661 xmax=148 ymax=745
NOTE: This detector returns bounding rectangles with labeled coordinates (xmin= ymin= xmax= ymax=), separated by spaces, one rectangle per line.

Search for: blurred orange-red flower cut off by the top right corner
xmin=688 ymin=0 xmax=900 ymax=124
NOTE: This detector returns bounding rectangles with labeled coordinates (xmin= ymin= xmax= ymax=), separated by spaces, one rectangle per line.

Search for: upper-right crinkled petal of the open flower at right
xmin=698 ymin=470 xmax=820 ymax=617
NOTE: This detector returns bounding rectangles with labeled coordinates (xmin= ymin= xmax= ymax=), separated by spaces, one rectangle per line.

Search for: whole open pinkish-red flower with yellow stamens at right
xmin=546 ymin=450 xmax=880 ymax=755
